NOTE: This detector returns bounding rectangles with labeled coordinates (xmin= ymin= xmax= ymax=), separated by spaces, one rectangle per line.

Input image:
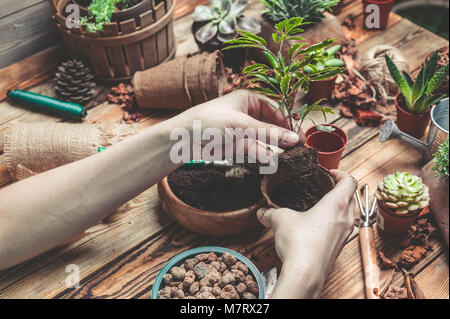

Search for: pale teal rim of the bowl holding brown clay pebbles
xmin=152 ymin=246 xmax=266 ymax=299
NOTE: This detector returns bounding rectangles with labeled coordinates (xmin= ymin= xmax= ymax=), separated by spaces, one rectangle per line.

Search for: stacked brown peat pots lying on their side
xmin=132 ymin=51 xmax=227 ymax=110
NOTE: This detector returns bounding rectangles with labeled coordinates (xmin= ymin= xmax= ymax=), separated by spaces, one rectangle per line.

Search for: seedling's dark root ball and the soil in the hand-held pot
xmin=271 ymin=145 xmax=334 ymax=212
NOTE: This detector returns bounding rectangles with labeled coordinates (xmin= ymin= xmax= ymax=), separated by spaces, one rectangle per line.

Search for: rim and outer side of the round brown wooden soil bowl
xmin=158 ymin=177 xmax=264 ymax=236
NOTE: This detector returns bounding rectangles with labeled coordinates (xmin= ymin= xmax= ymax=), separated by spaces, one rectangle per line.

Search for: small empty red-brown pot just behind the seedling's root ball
xmin=305 ymin=124 xmax=348 ymax=169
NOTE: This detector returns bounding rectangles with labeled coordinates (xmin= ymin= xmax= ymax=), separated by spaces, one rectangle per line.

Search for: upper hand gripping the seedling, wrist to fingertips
xmin=172 ymin=90 xmax=305 ymax=159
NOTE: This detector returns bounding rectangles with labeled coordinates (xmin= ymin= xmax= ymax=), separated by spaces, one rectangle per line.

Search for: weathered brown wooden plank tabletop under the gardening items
xmin=0 ymin=0 xmax=449 ymax=298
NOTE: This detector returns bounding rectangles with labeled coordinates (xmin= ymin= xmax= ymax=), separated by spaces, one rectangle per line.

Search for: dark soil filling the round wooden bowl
xmin=168 ymin=164 xmax=264 ymax=212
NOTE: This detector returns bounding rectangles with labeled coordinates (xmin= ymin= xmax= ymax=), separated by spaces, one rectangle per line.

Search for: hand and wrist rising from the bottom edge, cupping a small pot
xmin=258 ymin=170 xmax=357 ymax=298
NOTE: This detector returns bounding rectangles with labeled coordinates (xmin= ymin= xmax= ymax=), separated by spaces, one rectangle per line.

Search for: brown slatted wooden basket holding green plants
xmin=50 ymin=0 xmax=176 ymax=82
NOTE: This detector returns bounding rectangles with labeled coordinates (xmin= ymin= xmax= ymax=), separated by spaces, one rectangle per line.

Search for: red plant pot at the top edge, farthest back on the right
xmin=362 ymin=0 xmax=395 ymax=30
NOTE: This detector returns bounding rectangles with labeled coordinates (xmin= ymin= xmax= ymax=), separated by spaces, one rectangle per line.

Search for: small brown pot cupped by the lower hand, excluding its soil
xmin=261 ymin=166 xmax=336 ymax=208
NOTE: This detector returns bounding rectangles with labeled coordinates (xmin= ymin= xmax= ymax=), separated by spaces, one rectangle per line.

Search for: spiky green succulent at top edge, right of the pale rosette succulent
xmin=261 ymin=0 xmax=340 ymax=23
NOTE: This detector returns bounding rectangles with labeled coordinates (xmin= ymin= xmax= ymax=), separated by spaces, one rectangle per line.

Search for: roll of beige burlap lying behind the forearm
xmin=3 ymin=123 xmax=137 ymax=180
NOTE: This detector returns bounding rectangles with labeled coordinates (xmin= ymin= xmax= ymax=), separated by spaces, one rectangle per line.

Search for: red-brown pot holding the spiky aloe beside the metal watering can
xmin=395 ymin=93 xmax=430 ymax=139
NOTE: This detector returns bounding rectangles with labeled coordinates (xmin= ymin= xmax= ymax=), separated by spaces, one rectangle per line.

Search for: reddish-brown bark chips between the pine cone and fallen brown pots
xmin=108 ymin=83 xmax=144 ymax=124
